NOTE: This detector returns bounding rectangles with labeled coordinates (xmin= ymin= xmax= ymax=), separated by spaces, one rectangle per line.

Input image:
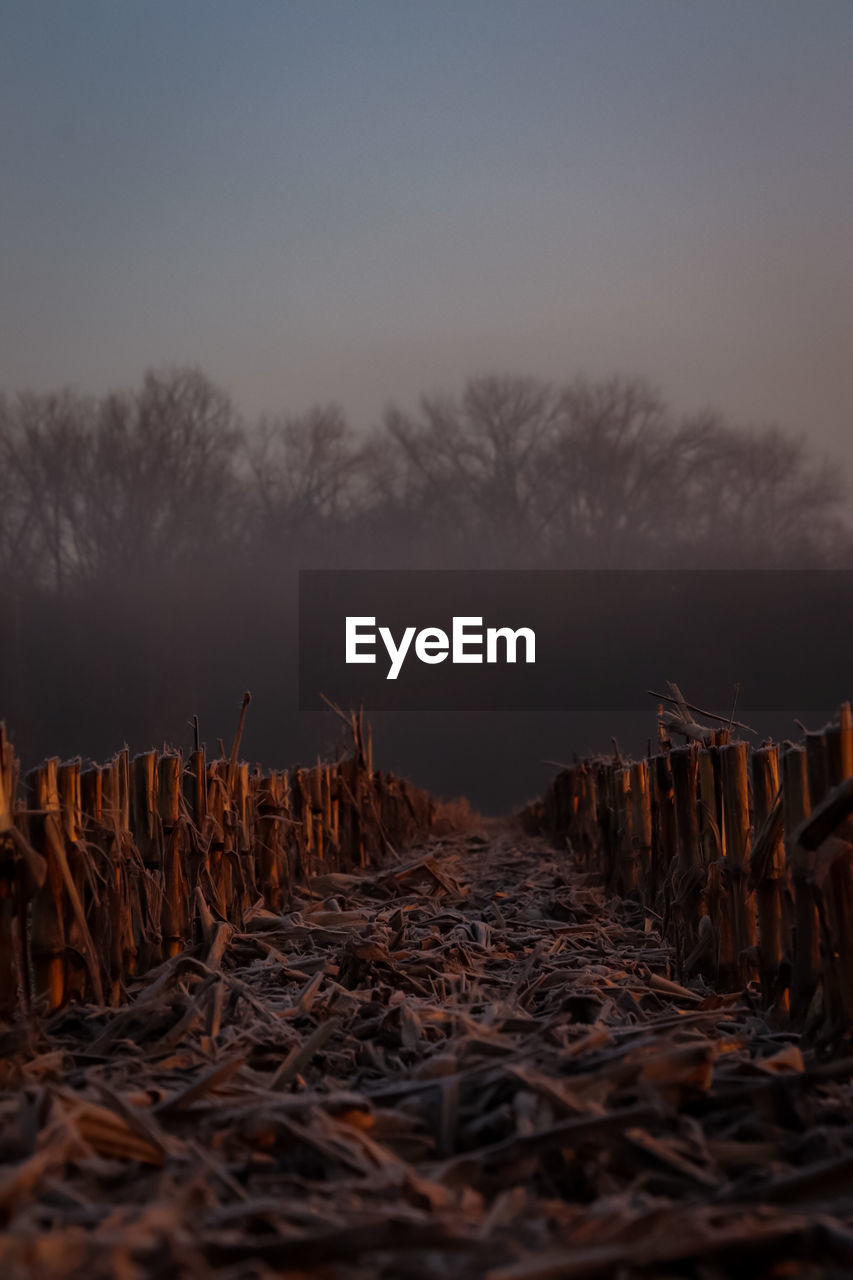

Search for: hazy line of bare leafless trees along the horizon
xmin=0 ymin=369 xmax=850 ymax=594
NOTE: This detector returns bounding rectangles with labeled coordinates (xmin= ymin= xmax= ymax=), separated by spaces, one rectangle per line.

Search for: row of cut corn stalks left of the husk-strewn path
xmin=0 ymin=717 xmax=433 ymax=1019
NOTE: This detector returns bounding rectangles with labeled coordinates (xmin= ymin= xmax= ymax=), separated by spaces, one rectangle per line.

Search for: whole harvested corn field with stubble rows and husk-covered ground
xmin=0 ymin=707 xmax=853 ymax=1280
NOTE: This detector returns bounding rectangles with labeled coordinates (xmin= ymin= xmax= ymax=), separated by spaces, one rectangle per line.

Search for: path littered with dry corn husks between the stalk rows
xmin=0 ymin=823 xmax=853 ymax=1280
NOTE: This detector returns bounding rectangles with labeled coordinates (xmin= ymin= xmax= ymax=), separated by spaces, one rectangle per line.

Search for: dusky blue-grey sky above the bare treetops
xmin=0 ymin=0 xmax=853 ymax=460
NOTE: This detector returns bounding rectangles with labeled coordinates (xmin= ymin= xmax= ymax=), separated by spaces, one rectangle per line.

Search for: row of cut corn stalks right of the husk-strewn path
xmin=525 ymin=704 xmax=853 ymax=1041
